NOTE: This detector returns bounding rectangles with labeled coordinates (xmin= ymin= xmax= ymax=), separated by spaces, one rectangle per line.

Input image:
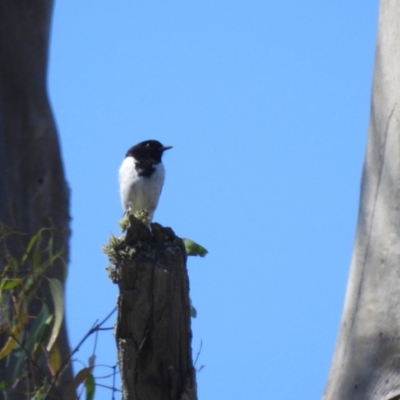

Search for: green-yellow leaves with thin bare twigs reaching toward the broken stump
xmin=0 ymin=224 xmax=116 ymax=400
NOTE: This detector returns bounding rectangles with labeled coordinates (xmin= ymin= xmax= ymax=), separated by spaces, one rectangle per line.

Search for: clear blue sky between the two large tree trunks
xmin=49 ymin=0 xmax=378 ymax=400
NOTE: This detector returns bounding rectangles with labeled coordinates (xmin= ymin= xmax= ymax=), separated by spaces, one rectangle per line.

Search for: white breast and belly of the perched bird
xmin=119 ymin=157 xmax=165 ymax=220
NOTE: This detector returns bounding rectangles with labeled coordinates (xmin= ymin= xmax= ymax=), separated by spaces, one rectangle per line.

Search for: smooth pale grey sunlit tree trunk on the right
xmin=323 ymin=0 xmax=400 ymax=400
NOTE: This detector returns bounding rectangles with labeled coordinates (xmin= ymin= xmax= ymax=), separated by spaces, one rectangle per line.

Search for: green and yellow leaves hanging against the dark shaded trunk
xmin=0 ymin=225 xmax=65 ymax=399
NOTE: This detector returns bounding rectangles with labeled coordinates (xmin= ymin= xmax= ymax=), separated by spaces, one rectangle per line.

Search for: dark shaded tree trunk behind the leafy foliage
xmin=0 ymin=0 xmax=72 ymax=400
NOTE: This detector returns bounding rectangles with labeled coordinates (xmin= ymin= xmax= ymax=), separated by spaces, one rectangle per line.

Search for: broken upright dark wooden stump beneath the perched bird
xmin=116 ymin=219 xmax=197 ymax=400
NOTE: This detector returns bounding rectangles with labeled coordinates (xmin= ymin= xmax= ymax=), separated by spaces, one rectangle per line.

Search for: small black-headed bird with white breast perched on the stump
xmin=119 ymin=140 xmax=172 ymax=221
